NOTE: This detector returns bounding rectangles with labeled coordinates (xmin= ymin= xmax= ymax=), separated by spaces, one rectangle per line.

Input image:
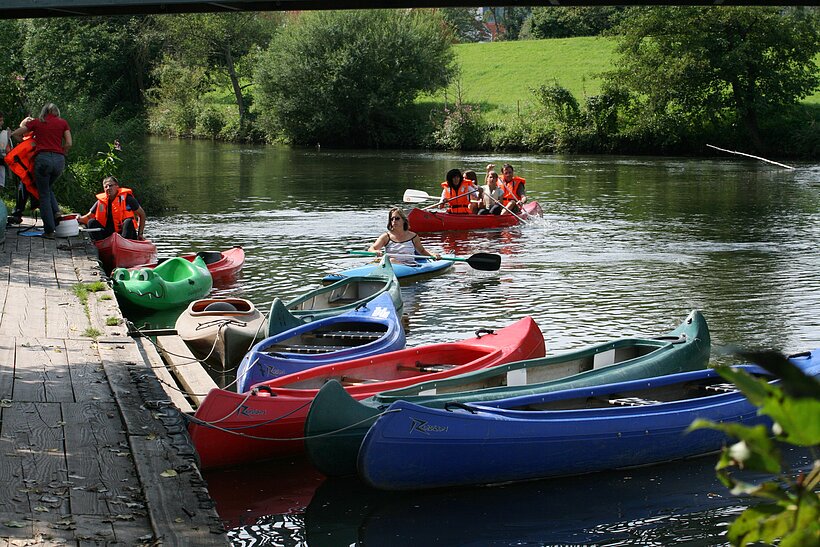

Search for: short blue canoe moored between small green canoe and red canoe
xmin=236 ymin=293 xmax=405 ymax=393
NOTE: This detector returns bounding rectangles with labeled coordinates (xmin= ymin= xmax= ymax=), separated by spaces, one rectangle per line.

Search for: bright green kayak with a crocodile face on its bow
xmin=111 ymin=257 xmax=213 ymax=310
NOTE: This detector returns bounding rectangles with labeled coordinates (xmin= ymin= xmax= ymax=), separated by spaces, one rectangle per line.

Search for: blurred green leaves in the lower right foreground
xmin=690 ymin=352 xmax=820 ymax=547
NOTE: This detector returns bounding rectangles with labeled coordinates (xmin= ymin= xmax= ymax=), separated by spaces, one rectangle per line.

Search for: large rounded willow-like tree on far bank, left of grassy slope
xmin=256 ymin=10 xmax=454 ymax=146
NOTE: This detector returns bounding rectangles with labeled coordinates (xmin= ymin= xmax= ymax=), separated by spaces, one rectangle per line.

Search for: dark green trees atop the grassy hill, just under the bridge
xmin=519 ymin=6 xmax=626 ymax=40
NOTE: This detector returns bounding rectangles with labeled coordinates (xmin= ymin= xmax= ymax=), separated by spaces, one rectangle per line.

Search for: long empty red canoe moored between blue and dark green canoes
xmin=188 ymin=317 xmax=545 ymax=469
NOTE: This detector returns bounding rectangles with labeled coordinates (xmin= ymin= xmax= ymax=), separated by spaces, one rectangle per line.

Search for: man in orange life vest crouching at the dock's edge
xmin=77 ymin=177 xmax=146 ymax=240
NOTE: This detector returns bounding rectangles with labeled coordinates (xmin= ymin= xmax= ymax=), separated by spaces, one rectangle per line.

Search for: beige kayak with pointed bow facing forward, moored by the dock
xmin=175 ymin=298 xmax=265 ymax=370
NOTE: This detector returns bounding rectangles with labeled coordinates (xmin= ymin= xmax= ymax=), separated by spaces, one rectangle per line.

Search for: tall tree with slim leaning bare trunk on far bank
xmin=157 ymin=12 xmax=279 ymax=135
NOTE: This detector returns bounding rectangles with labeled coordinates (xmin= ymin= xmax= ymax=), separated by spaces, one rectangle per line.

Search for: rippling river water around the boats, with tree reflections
xmin=138 ymin=139 xmax=820 ymax=545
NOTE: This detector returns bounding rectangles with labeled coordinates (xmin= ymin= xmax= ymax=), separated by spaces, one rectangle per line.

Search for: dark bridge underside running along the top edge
xmin=0 ymin=0 xmax=800 ymax=19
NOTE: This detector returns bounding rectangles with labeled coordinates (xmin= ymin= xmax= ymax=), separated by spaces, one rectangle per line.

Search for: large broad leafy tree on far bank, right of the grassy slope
xmin=609 ymin=7 xmax=820 ymax=152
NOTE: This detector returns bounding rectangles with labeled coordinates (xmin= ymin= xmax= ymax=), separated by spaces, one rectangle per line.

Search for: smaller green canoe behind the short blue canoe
xmin=268 ymin=257 xmax=404 ymax=337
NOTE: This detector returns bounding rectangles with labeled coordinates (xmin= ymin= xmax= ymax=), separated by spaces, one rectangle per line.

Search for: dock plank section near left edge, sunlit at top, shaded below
xmin=12 ymin=337 xmax=73 ymax=402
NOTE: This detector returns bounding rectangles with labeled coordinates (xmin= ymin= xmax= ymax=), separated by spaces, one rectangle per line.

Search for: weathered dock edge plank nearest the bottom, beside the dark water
xmin=131 ymin=437 xmax=226 ymax=546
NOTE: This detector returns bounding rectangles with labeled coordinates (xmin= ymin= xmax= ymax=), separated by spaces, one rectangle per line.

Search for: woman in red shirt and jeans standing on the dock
xmin=12 ymin=103 xmax=73 ymax=238
